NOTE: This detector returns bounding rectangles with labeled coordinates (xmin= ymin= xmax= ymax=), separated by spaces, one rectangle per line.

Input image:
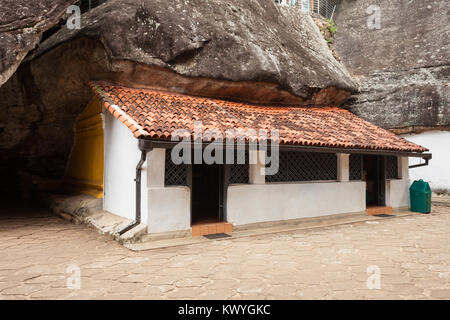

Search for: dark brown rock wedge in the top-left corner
xmin=0 ymin=0 xmax=77 ymax=86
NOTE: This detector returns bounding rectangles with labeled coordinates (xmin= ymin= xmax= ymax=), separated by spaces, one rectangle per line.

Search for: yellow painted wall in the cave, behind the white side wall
xmin=64 ymin=98 xmax=104 ymax=198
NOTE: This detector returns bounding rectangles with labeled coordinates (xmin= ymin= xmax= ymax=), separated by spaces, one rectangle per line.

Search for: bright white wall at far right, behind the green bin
xmin=402 ymin=131 xmax=450 ymax=189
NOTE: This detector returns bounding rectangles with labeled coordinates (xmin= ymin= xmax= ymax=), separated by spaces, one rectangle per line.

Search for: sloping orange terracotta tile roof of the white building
xmin=90 ymin=83 xmax=427 ymax=152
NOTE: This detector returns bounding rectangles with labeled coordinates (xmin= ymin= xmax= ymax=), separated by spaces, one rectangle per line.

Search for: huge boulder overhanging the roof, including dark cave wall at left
xmin=0 ymin=0 xmax=356 ymax=195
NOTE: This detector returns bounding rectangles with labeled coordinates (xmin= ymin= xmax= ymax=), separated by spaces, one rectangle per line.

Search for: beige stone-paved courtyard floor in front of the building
xmin=0 ymin=201 xmax=450 ymax=299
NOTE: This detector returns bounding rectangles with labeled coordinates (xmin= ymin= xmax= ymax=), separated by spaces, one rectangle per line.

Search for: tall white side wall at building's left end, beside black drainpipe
xmin=103 ymin=112 xmax=147 ymax=224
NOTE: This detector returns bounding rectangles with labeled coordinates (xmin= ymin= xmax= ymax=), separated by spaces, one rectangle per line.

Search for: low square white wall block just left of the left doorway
xmin=147 ymin=186 xmax=191 ymax=233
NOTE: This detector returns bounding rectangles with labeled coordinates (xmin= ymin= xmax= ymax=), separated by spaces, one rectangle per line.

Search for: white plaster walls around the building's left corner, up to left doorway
xmin=103 ymin=120 xmax=191 ymax=233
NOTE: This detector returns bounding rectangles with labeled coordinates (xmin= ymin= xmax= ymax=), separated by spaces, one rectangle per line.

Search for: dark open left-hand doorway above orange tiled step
xmin=191 ymin=164 xmax=223 ymax=224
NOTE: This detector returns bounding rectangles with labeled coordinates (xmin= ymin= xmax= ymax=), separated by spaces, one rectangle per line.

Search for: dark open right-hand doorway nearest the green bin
xmin=363 ymin=155 xmax=386 ymax=206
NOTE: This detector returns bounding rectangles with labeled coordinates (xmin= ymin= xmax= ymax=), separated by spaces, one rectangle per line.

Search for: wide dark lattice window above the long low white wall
xmin=266 ymin=151 xmax=337 ymax=182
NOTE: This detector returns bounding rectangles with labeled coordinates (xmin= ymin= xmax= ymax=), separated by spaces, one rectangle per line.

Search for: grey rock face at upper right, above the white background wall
xmin=334 ymin=0 xmax=450 ymax=133
